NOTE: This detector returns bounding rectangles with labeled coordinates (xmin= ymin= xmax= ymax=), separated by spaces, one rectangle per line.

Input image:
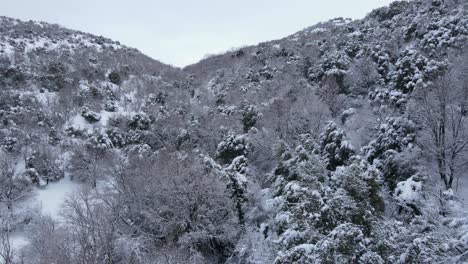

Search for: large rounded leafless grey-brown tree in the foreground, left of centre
xmin=104 ymin=151 xmax=237 ymax=262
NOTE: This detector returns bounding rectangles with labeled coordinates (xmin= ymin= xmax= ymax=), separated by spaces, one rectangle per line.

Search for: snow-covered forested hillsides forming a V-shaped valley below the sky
xmin=0 ymin=0 xmax=468 ymax=264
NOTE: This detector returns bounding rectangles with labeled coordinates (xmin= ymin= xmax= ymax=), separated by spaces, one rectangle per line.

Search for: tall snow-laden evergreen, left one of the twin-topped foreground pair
xmin=270 ymin=146 xmax=327 ymax=263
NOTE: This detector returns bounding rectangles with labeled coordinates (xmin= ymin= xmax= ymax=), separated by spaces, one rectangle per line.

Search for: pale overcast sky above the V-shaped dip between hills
xmin=0 ymin=0 xmax=392 ymax=66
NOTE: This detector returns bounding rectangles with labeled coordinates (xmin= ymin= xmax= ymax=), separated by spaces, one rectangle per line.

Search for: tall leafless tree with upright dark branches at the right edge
xmin=412 ymin=70 xmax=468 ymax=189
